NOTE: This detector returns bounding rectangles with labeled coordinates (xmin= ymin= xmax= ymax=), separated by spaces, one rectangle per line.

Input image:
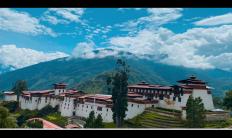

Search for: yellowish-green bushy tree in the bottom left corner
xmin=0 ymin=107 xmax=17 ymax=128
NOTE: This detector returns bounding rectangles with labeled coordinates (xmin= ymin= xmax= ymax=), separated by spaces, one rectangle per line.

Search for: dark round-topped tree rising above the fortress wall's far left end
xmin=12 ymin=80 xmax=28 ymax=103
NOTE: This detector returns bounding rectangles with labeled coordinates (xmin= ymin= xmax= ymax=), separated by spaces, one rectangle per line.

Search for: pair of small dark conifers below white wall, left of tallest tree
xmin=84 ymin=111 xmax=104 ymax=128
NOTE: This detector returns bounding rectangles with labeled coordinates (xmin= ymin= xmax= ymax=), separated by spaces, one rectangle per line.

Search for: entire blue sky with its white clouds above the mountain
xmin=0 ymin=8 xmax=232 ymax=70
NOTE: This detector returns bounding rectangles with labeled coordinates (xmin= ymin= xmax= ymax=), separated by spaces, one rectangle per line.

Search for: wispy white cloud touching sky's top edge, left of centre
xmin=42 ymin=8 xmax=84 ymax=24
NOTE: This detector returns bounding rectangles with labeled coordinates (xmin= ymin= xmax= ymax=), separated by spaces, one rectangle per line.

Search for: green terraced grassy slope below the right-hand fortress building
xmin=128 ymin=108 xmax=184 ymax=128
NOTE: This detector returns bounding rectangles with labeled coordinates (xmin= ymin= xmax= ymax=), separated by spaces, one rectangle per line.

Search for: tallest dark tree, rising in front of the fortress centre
xmin=107 ymin=59 xmax=129 ymax=127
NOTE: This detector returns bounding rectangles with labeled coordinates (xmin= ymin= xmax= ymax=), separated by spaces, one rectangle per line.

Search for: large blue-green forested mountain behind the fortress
xmin=0 ymin=57 xmax=232 ymax=96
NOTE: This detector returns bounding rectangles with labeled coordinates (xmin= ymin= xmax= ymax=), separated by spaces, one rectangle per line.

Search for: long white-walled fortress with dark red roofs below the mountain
xmin=11 ymin=76 xmax=214 ymax=122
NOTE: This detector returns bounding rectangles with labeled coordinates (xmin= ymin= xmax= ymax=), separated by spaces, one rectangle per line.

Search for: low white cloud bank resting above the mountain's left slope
xmin=0 ymin=45 xmax=68 ymax=69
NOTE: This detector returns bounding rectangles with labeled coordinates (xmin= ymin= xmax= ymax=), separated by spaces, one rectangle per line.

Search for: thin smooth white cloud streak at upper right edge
xmin=194 ymin=13 xmax=232 ymax=26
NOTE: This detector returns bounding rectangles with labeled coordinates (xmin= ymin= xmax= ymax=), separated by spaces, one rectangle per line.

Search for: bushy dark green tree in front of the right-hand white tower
xmin=186 ymin=95 xmax=205 ymax=128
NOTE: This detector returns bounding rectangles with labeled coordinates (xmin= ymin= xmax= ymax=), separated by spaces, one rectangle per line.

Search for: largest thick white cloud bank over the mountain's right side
xmin=109 ymin=25 xmax=232 ymax=70
